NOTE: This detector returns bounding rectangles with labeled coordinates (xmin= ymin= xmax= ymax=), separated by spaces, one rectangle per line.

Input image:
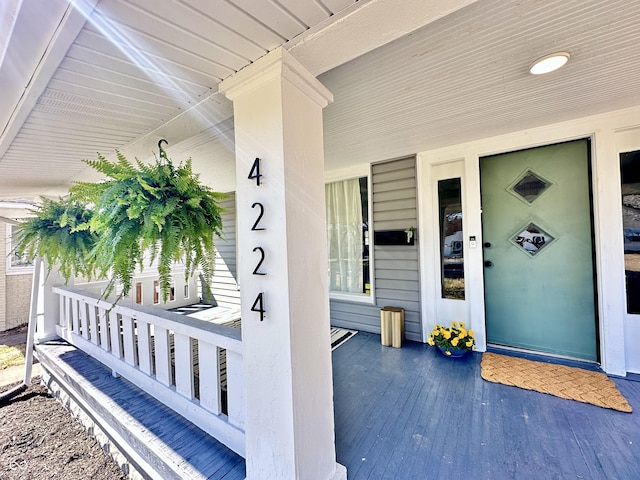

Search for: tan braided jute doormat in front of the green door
xmin=481 ymin=353 xmax=632 ymax=413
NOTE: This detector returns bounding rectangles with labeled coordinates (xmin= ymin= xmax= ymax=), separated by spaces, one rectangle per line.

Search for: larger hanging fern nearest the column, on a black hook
xmin=71 ymin=152 xmax=227 ymax=302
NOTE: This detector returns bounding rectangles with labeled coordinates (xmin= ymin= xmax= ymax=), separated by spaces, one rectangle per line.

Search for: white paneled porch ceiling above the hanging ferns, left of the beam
xmin=0 ymin=0 xmax=370 ymax=198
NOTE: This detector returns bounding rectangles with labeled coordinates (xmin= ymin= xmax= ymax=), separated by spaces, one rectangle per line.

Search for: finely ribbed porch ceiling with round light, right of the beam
xmin=319 ymin=0 xmax=640 ymax=168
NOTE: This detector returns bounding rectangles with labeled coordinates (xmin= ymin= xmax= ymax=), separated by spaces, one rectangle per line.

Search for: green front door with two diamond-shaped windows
xmin=480 ymin=140 xmax=598 ymax=361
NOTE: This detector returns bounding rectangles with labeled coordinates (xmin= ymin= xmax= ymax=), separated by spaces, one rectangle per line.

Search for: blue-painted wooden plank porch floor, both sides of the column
xmin=38 ymin=322 xmax=640 ymax=480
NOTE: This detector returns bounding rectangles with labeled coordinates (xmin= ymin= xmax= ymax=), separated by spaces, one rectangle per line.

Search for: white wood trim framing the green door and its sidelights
xmin=418 ymin=108 xmax=640 ymax=376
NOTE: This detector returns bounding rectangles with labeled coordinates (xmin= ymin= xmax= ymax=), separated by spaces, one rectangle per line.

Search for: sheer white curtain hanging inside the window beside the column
xmin=325 ymin=178 xmax=363 ymax=293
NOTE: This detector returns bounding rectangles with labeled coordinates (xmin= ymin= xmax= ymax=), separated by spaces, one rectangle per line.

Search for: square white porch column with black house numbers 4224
xmin=220 ymin=49 xmax=346 ymax=480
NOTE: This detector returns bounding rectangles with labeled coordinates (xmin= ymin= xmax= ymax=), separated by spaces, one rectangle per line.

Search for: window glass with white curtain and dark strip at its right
xmin=325 ymin=177 xmax=371 ymax=296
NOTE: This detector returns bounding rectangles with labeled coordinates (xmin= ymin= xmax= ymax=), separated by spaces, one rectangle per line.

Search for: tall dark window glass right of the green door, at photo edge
xmin=620 ymin=150 xmax=640 ymax=313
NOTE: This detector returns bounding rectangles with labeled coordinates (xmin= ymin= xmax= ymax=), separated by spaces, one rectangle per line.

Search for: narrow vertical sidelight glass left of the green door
xmin=438 ymin=178 xmax=464 ymax=300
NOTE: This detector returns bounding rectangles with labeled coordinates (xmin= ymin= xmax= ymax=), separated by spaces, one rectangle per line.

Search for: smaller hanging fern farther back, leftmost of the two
xmin=13 ymin=197 xmax=98 ymax=281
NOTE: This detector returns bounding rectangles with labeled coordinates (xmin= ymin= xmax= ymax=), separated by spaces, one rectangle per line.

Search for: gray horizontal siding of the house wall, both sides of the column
xmin=211 ymin=182 xmax=422 ymax=341
